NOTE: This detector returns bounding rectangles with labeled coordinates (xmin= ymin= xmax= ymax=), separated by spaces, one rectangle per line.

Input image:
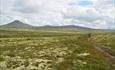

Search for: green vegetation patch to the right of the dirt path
xmin=93 ymin=33 xmax=115 ymax=56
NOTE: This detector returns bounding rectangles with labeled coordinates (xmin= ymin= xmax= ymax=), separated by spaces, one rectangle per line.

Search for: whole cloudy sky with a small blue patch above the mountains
xmin=0 ymin=0 xmax=115 ymax=29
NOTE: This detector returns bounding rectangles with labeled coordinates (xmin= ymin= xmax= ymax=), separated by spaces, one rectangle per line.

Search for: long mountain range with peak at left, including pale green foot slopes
xmin=0 ymin=20 xmax=115 ymax=32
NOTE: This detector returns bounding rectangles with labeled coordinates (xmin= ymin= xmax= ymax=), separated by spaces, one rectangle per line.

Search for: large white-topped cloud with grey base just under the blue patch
xmin=63 ymin=7 xmax=102 ymax=22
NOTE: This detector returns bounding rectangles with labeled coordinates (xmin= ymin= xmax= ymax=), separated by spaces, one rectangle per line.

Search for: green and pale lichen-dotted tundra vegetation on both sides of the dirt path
xmin=0 ymin=30 xmax=115 ymax=70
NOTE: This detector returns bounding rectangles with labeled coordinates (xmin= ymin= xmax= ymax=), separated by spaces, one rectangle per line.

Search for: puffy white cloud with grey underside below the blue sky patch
xmin=63 ymin=8 xmax=103 ymax=22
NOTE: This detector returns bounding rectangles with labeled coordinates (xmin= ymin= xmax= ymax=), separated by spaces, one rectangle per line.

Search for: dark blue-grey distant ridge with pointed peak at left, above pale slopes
xmin=1 ymin=20 xmax=91 ymax=29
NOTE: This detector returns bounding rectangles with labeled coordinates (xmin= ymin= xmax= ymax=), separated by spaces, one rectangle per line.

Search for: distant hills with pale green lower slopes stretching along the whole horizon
xmin=0 ymin=20 xmax=115 ymax=32
